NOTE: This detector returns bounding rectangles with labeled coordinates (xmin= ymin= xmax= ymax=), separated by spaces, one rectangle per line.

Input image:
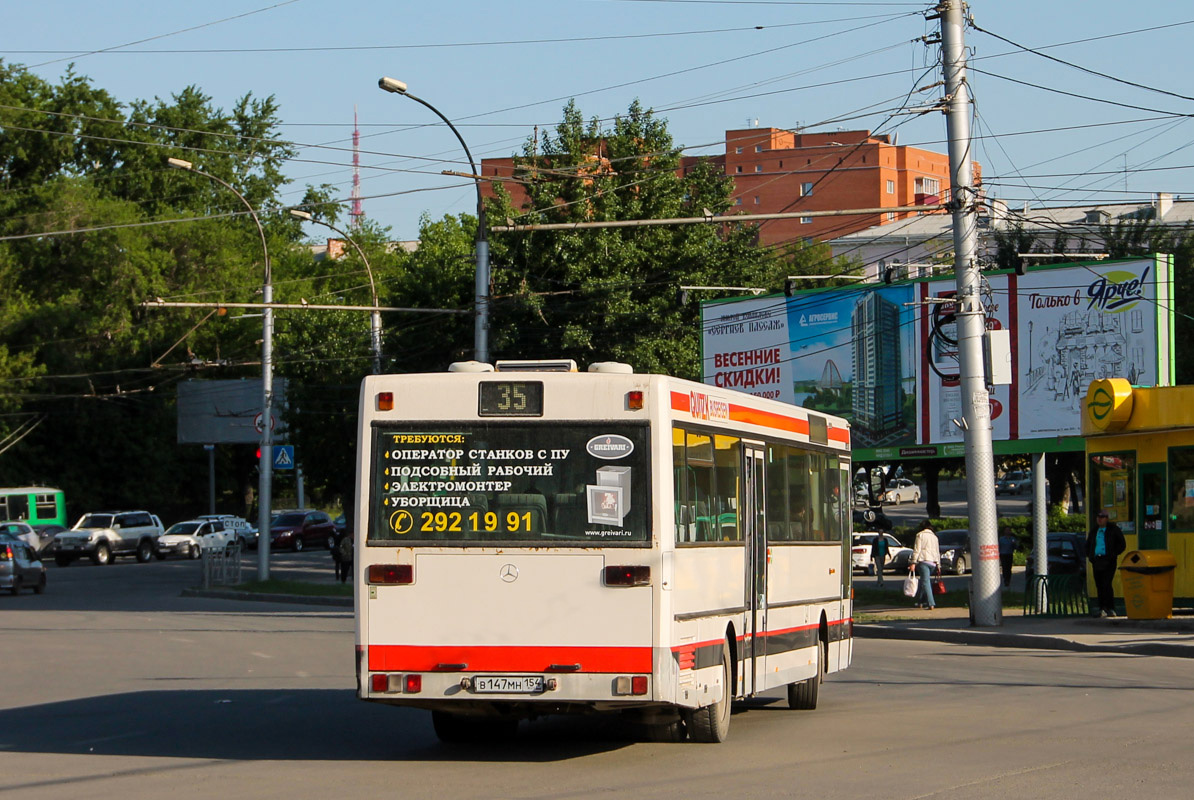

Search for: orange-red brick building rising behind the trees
xmin=481 ymin=128 xmax=981 ymax=245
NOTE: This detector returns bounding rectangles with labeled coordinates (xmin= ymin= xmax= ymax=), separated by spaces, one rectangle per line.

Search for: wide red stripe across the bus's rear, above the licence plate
xmin=369 ymin=645 xmax=652 ymax=672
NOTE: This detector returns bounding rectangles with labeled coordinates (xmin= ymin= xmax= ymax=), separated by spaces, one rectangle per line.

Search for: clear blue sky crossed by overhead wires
xmin=9 ymin=0 xmax=1194 ymax=239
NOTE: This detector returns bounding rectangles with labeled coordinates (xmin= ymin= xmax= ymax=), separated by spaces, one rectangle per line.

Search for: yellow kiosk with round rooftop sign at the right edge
xmin=1082 ymin=379 xmax=1194 ymax=613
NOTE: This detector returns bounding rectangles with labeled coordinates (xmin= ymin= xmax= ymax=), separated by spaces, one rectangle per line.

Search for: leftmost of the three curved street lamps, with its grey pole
xmin=166 ymin=159 xmax=273 ymax=580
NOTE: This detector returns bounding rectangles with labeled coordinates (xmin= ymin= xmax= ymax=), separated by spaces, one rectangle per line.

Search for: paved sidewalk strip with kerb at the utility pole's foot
xmin=854 ymin=607 xmax=1194 ymax=658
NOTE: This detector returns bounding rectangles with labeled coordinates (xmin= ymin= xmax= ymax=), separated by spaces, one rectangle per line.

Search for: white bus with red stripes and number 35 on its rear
xmin=355 ymin=362 xmax=853 ymax=741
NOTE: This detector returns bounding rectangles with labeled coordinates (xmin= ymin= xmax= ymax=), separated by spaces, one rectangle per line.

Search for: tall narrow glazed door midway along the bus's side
xmin=739 ymin=442 xmax=767 ymax=695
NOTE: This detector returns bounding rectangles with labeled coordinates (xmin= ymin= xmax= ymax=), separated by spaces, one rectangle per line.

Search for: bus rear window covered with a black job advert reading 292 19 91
xmin=368 ymin=423 xmax=651 ymax=547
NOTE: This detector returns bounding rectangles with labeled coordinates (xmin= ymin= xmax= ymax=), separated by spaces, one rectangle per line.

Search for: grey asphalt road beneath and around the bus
xmin=0 ymin=553 xmax=1194 ymax=800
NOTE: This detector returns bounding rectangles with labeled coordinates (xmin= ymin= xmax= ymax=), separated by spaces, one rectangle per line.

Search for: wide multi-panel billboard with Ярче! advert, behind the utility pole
xmin=702 ymin=256 xmax=1174 ymax=460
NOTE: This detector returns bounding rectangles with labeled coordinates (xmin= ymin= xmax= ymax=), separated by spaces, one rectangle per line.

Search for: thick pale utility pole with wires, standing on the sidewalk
xmin=936 ymin=0 xmax=1003 ymax=627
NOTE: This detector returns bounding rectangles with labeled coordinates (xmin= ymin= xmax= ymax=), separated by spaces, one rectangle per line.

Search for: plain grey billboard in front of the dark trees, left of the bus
xmin=178 ymin=377 xmax=287 ymax=444
